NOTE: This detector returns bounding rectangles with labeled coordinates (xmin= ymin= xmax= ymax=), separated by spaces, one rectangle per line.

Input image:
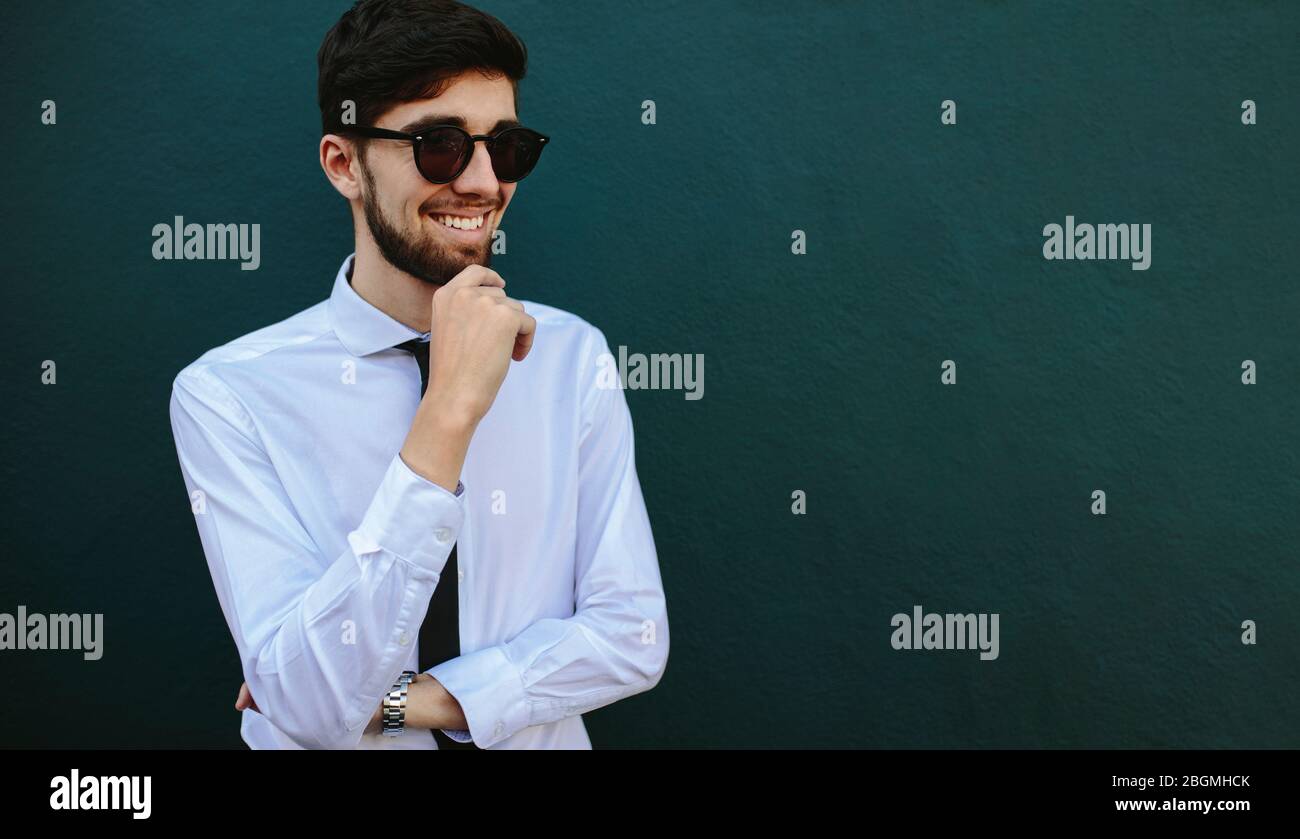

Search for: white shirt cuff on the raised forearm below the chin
xmin=347 ymin=454 xmax=465 ymax=575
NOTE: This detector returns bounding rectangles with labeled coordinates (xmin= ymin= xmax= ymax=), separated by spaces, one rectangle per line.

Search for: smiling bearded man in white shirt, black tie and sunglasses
xmin=172 ymin=0 xmax=668 ymax=749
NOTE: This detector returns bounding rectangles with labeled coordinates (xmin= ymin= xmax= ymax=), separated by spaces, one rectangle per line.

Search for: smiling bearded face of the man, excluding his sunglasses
xmin=358 ymin=70 xmax=517 ymax=285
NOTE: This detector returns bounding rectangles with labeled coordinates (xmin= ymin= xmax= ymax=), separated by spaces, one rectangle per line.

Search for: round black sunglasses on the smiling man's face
xmin=341 ymin=125 xmax=551 ymax=183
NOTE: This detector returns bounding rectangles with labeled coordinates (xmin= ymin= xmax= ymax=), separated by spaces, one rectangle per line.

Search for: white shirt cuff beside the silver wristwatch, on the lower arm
xmin=425 ymin=646 xmax=529 ymax=749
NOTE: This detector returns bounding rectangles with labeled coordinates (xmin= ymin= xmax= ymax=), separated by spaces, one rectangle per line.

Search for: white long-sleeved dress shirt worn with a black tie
xmin=172 ymin=255 xmax=668 ymax=749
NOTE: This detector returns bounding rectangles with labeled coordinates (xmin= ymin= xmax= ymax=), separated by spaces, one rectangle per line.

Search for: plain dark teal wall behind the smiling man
xmin=0 ymin=0 xmax=1300 ymax=748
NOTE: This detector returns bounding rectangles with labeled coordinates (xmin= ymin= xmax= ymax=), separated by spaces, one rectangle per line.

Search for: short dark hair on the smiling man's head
xmin=316 ymin=0 xmax=528 ymax=148
